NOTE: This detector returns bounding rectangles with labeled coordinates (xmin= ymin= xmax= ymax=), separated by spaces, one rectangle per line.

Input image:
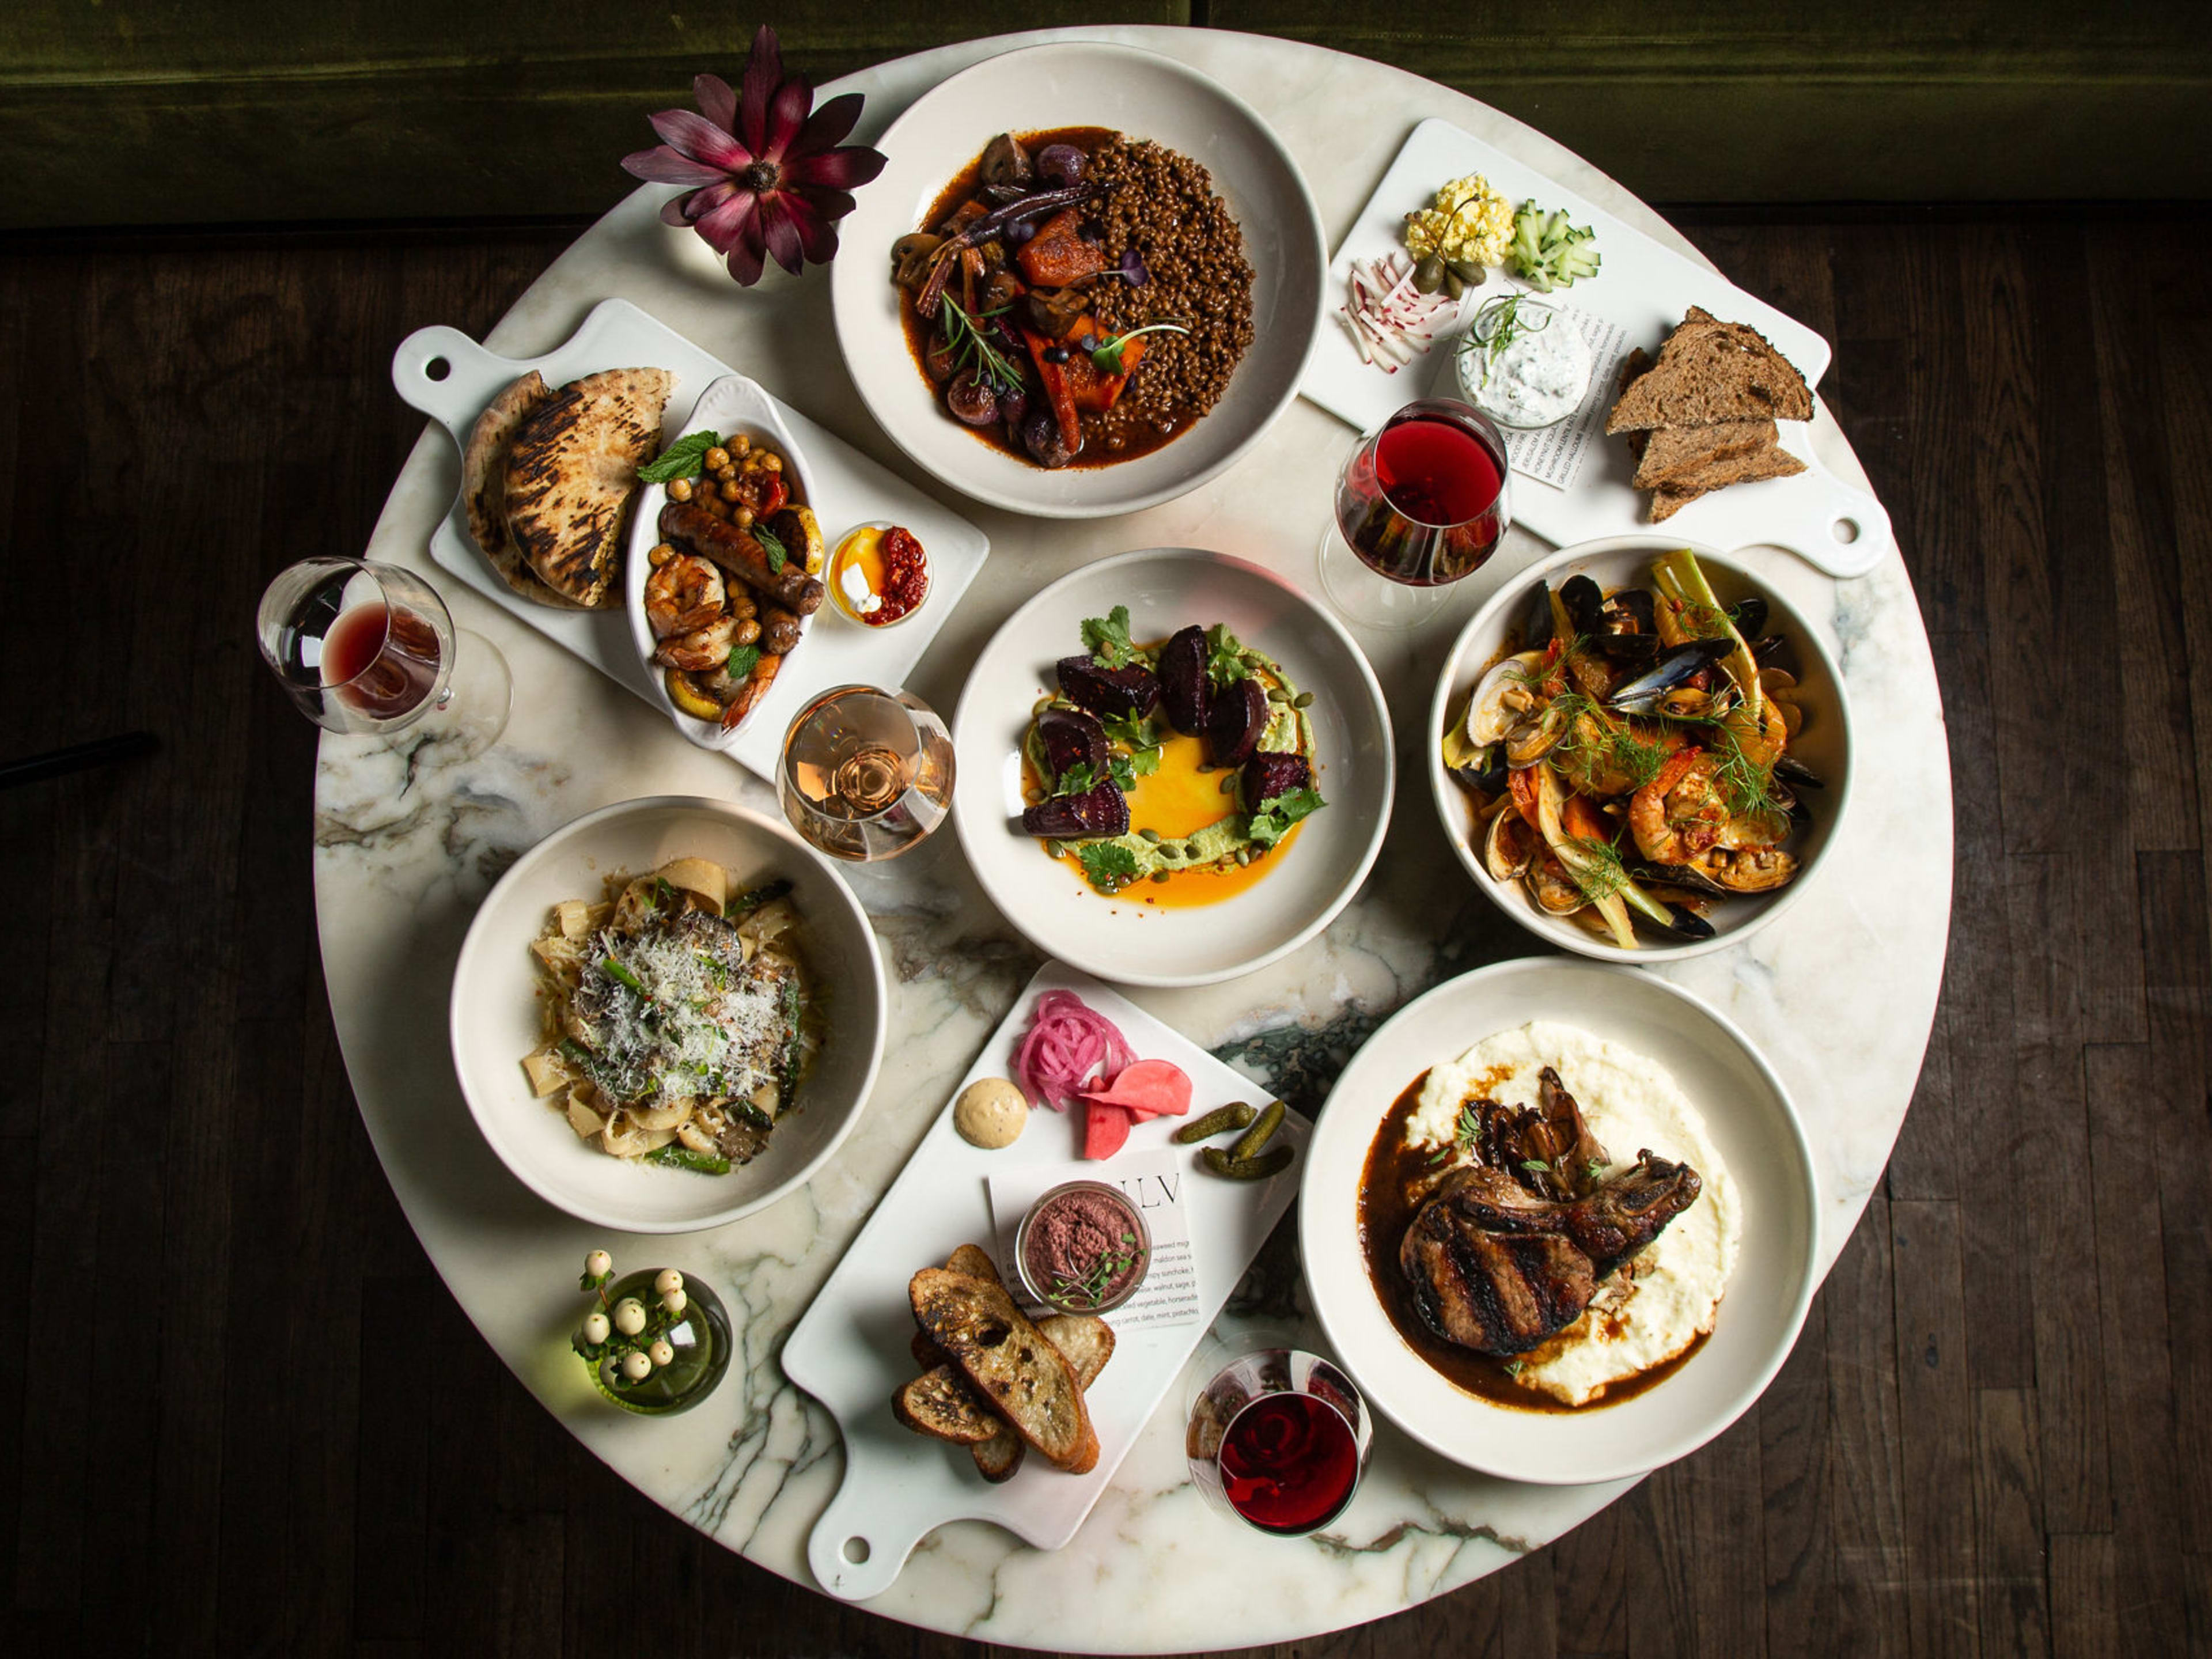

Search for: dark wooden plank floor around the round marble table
xmin=0 ymin=213 xmax=2212 ymax=1659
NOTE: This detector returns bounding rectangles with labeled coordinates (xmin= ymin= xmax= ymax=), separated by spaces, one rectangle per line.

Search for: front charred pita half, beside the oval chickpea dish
xmin=506 ymin=369 xmax=675 ymax=611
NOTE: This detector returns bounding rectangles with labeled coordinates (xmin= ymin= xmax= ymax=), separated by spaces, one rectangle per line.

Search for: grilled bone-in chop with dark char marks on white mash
xmin=1398 ymin=1153 xmax=1703 ymax=1356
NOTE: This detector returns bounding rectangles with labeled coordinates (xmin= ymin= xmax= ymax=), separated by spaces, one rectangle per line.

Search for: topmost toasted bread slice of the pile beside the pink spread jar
xmin=907 ymin=1267 xmax=1099 ymax=1475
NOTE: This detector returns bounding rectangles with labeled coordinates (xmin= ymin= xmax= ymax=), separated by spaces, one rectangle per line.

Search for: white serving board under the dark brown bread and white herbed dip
xmin=1298 ymin=119 xmax=1889 ymax=577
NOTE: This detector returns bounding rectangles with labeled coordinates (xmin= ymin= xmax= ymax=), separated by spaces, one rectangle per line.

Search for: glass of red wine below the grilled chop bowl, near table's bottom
xmin=1183 ymin=1347 xmax=1374 ymax=1537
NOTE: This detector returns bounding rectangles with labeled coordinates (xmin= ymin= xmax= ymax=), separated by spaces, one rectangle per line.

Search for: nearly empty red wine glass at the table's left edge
xmin=255 ymin=555 xmax=513 ymax=759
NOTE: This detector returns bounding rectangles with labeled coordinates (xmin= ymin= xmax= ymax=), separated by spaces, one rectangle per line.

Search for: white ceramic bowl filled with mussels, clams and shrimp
xmin=1427 ymin=531 xmax=1851 ymax=964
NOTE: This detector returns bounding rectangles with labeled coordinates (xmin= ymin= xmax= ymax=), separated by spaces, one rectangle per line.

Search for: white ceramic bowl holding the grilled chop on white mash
xmin=1298 ymin=956 xmax=1820 ymax=1486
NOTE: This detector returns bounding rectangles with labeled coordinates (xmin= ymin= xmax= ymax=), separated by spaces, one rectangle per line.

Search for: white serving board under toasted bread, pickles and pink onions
xmin=783 ymin=962 xmax=1307 ymax=1601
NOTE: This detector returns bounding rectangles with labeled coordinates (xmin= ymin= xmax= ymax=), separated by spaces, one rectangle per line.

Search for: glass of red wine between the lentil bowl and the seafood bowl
xmin=1320 ymin=398 xmax=1513 ymax=628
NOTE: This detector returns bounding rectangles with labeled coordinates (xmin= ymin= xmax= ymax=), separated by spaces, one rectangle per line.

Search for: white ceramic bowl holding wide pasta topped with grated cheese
xmin=451 ymin=794 xmax=889 ymax=1232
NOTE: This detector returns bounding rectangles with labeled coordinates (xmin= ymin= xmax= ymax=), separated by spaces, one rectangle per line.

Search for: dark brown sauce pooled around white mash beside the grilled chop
xmin=1361 ymin=1073 xmax=1706 ymax=1416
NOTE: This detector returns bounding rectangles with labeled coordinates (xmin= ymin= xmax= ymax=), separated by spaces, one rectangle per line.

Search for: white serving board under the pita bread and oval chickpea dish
xmin=392 ymin=298 xmax=991 ymax=781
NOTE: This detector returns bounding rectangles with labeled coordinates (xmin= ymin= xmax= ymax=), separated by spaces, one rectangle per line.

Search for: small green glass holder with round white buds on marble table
xmin=571 ymin=1250 xmax=732 ymax=1418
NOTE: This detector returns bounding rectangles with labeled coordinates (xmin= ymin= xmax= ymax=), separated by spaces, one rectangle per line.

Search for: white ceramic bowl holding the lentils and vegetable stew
xmin=832 ymin=42 xmax=1330 ymax=518
